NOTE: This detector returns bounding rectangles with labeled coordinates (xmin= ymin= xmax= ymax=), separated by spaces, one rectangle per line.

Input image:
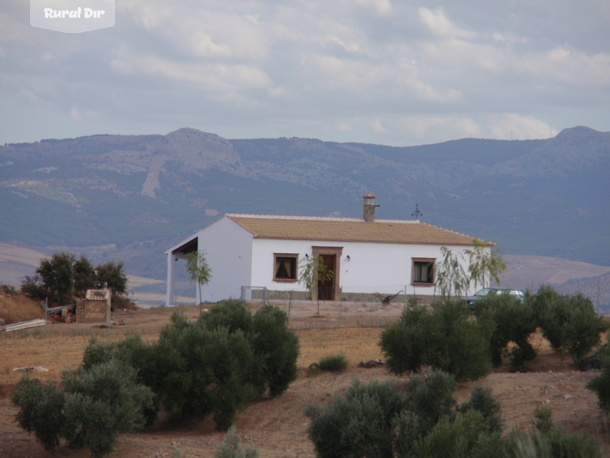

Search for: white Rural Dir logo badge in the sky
xmin=30 ymin=0 xmax=115 ymax=33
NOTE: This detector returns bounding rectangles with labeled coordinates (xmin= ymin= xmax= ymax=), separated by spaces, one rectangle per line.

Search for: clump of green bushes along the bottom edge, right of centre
xmin=305 ymin=371 xmax=601 ymax=458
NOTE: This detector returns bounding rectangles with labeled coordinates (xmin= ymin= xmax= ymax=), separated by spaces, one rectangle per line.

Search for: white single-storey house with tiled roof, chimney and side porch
xmin=166 ymin=194 xmax=493 ymax=306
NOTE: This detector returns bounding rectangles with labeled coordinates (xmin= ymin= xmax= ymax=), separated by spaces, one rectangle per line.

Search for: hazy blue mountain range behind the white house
xmin=0 ymin=127 xmax=610 ymax=278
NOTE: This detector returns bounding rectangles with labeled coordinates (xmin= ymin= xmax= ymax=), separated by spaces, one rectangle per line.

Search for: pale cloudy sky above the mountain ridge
xmin=0 ymin=0 xmax=610 ymax=146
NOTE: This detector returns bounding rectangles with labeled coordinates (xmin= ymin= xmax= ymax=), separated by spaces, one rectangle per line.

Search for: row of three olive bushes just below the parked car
xmin=380 ymin=286 xmax=605 ymax=380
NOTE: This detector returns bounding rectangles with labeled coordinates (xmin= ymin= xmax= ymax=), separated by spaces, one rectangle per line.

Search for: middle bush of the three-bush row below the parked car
xmin=475 ymin=294 xmax=538 ymax=369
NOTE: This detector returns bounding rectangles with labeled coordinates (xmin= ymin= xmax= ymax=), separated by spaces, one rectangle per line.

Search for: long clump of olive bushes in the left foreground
xmin=14 ymin=301 xmax=299 ymax=454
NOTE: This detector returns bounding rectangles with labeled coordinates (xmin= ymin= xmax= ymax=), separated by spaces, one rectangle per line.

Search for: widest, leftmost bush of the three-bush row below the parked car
xmin=380 ymin=301 xmax=491 ymax=381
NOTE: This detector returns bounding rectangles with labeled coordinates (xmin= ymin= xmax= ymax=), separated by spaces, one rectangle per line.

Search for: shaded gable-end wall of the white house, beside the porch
xmin=198 ymin=217 xmax=252 ymax=302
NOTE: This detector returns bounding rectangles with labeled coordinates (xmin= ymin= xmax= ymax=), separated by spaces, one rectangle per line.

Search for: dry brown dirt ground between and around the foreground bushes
xmin=0 ymin=302 xmax=610 ymax=457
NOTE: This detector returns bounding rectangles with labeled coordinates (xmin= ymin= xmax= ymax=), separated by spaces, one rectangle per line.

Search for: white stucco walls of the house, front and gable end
xmin=168 ymin=217 xmax=490 ymax=302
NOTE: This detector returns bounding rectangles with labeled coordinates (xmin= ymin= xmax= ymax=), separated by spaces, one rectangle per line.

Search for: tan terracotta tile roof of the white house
xmin=226 ymin=214 xmax=494 ymax=246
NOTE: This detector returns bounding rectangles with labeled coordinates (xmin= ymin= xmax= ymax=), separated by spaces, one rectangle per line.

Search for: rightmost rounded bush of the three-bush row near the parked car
xmin=534 ymin=287 xmax=604 ymax=364
